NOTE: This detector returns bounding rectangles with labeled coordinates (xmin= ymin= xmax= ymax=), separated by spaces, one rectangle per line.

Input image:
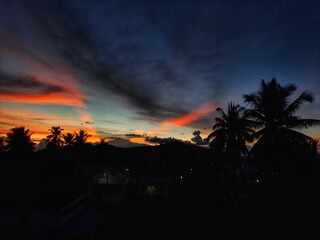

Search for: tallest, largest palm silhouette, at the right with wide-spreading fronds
xmin=243 ymin=78 xmax=320 ymax=181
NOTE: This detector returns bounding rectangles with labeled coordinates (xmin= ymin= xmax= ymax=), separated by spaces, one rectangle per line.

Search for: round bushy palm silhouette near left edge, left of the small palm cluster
xmin=6 ymin=127 xmax=34 ymax=153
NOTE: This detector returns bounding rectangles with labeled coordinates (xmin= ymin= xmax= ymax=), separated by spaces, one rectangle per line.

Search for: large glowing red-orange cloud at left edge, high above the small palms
xmin=0 ymin=48 xmax=89 ymax=106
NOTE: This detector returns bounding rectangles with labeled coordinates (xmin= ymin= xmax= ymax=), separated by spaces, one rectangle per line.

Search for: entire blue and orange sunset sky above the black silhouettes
xmin=0 ymin=0 xmax=320 ymax=145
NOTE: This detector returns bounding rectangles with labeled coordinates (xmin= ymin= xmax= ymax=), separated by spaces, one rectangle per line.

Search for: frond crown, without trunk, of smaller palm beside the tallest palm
xmin=207 ymin=102 xmax=254 ymax=158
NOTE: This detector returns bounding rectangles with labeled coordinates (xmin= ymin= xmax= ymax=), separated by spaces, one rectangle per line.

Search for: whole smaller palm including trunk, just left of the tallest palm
xmin=207 ymin=102 xmax=254 ymax=200
